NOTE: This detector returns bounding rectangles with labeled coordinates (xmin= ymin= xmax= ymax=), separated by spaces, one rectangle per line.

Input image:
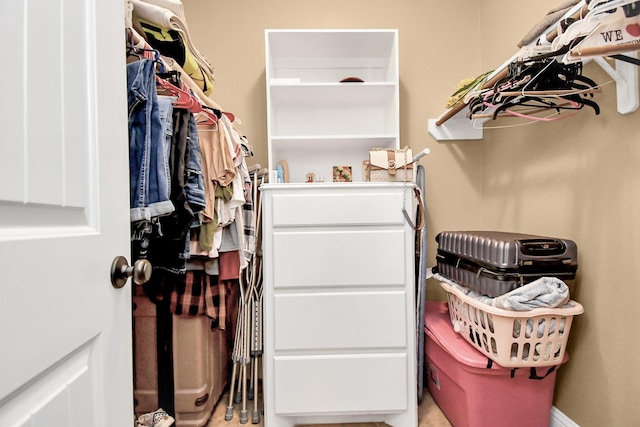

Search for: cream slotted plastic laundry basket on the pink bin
xmin=440 ymin=282 xmax=584 ymax=367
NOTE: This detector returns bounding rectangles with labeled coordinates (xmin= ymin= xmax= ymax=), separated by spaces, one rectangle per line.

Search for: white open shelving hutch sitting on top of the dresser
xmin=265 ymin=30 xmax=400 ymax=183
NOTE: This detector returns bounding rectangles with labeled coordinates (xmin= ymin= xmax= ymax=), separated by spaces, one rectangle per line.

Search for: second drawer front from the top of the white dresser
xmin=272 ymin=230 xmax=404 ymax=289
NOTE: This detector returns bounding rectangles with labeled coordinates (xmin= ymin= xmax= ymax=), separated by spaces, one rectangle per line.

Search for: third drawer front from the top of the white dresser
xmin=273 ymin=291 xmax=407 ymax=351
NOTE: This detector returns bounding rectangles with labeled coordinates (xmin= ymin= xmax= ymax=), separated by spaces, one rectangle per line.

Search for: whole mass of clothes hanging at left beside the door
xmin=126 ymin=0 xmax=256 ymax=422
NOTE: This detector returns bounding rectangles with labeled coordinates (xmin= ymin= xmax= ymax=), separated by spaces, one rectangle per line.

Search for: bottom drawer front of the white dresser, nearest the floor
xmin=274 ymin=354 xmax=408 ymax=415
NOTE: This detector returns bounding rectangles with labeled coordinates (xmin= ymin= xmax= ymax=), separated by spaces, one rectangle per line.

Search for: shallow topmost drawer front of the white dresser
xmin=272 ymin=190 xmax=404 ymax=227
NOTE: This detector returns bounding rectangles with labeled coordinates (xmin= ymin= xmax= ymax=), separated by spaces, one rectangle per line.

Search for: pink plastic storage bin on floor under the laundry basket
xmin=425 ymin=301 xmax=567 ymax=427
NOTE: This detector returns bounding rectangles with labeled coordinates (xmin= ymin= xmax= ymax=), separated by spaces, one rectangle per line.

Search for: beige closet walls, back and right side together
xmin=183 ymin=0 xmax=640 ymax=427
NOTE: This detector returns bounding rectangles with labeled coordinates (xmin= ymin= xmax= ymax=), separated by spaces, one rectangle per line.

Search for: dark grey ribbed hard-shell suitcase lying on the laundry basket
xmin=436 ymin=231 xmax=578 ymax=297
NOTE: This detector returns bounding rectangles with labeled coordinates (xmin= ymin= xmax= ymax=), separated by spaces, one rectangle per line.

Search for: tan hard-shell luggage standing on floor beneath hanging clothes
xmin=133 ymin=295 xmax=230 ymax=427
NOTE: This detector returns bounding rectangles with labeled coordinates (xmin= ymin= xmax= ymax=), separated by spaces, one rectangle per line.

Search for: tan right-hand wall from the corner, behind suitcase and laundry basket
xmin=481 ymin=0 xmax=640 ymax=427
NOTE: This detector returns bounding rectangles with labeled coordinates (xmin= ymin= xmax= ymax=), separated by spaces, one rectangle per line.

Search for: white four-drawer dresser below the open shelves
xmin=261 ymin=183 xmax=417 ymax=427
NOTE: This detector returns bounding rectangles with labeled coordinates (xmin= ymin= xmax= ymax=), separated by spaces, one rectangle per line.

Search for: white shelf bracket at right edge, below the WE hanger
xmin=593 ymin=52 xmax=640 ymax=114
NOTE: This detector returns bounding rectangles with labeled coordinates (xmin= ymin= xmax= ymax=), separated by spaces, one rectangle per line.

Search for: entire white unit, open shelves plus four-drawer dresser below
xmin=260 ymin=30 xmax=417 ymax=427
